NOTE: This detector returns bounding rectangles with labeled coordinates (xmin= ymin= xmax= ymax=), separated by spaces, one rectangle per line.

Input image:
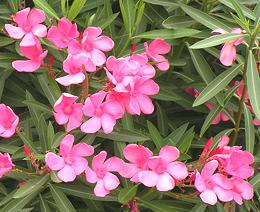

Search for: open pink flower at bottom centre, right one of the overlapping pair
xmin=138 ymin=146 xmax=188 ymax=191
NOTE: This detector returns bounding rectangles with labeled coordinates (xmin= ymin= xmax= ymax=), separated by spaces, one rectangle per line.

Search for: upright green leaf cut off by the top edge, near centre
xmin=119 ymin=0 xmax=136 ymax=37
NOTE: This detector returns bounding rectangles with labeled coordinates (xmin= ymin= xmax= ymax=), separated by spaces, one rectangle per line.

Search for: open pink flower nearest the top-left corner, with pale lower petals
xmin=5 ymin=7 xmax=47 ymax=46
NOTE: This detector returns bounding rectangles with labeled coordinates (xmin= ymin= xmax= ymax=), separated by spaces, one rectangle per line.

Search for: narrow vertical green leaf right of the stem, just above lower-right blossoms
xmin=244 ymin=104 xmax=255 ymax=154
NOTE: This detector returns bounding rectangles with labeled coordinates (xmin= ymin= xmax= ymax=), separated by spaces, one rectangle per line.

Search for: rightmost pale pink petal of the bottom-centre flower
xmin=167 ymin=162 xmax=188 ymax=180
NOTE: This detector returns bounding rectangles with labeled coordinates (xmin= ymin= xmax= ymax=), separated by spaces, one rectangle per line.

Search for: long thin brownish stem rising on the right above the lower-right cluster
xmin=230 ymin=25 xmax=260 ymax=146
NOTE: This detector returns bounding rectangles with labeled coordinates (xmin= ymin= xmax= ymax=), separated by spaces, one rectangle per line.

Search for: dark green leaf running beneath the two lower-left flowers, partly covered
xmin=56 ymin=184 xmax=117 ymax=202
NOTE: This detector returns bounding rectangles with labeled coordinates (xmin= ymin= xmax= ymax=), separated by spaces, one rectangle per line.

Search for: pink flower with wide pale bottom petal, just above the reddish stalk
xmin=56 ymin=54 xmax=88 ymax=86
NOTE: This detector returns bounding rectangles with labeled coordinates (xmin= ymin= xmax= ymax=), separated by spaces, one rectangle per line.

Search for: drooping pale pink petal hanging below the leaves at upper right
xmin=219 ymin=42 xmax=236 ymax=66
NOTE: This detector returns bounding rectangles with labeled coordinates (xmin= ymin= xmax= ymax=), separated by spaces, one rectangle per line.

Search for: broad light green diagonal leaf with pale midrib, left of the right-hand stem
xmin=193 ymin=64 xmax=242 ymax=107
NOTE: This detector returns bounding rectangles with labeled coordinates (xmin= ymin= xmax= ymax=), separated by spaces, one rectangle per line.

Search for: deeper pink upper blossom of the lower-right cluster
xmin=210 ymin=135 xmax=254 ymax=179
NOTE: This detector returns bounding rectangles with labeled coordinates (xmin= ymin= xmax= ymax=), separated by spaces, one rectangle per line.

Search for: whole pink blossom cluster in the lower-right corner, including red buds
xmin=195 ymin=135 xmax=254 ymax=205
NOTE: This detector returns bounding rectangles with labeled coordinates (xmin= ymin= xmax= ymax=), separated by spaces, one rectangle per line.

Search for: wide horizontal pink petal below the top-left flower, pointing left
xmin=12 ymin=60 xmax=41 ymax=72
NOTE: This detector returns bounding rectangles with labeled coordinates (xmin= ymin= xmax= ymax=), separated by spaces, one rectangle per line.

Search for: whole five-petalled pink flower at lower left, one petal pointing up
xmin=45 ymin=134 xmax=94 ymax=182
